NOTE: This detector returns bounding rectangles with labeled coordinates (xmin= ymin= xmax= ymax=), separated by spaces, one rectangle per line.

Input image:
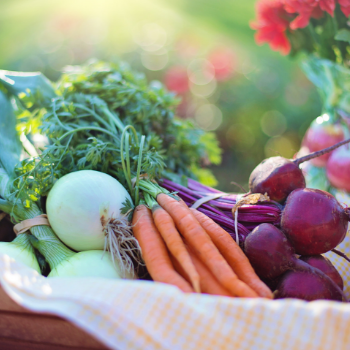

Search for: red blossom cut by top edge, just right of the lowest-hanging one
xmin=283 ymin=0 xmax=336 ymax=29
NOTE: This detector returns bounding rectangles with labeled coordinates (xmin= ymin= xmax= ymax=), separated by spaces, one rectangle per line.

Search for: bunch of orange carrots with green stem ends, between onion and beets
xmin=133 ymin=180 xmax=272 ymax=298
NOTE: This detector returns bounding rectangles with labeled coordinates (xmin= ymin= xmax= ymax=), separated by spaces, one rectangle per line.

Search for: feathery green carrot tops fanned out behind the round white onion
xmin=13 ymin=62 xmax=220 ymax=206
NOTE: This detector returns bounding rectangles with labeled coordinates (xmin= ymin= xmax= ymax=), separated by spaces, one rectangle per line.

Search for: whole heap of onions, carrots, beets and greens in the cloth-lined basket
xmin=0 ymin=62 xmax=349 ymax=300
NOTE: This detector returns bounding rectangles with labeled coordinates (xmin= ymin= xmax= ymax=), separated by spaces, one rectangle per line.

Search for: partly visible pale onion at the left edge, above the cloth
xmin=0 ymin=233 xmax=41 ymax=273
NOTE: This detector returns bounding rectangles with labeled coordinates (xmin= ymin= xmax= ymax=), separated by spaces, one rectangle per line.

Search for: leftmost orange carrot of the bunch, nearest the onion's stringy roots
xmin=132 ymin=205 xmax=194 ymax=293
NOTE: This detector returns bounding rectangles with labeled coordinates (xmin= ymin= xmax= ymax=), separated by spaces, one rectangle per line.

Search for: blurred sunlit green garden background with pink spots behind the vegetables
xmin=0 ymin=0 xmax=321 ymax=192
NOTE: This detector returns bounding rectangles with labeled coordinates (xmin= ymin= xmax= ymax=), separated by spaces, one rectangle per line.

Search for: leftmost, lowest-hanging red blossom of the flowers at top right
xmin=251 ymin=0 xmax=291 ymax=55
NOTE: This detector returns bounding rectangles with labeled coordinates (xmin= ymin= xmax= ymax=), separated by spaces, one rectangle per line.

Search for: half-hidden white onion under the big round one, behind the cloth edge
xmin=48 ymin=250 xmax=136 ymax=279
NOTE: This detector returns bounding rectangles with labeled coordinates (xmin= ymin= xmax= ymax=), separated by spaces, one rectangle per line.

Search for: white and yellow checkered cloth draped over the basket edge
xmin=0 ymin=230 xmax=350 ymax=350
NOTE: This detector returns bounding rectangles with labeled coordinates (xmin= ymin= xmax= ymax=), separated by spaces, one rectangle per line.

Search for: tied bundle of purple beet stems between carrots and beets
xmin=161 ymin=179 xmax=281 ymax=241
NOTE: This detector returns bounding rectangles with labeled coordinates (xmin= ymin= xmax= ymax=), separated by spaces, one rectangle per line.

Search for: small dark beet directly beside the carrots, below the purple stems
xmin=244 ymin=224 xmax=297 ymax=280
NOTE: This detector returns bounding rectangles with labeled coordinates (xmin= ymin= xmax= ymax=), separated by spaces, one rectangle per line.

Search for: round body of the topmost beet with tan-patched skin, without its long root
xmin=249 ymin=157 xmax=306 ymax=203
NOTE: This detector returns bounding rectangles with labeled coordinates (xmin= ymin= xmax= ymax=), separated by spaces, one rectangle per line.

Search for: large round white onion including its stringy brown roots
xmin=46 ymin=170 xmax=141 ymax=277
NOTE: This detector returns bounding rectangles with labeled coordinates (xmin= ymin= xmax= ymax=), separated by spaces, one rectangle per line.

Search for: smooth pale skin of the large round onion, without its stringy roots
xmin=46 ymin=170 xmax=132 ymax=251
